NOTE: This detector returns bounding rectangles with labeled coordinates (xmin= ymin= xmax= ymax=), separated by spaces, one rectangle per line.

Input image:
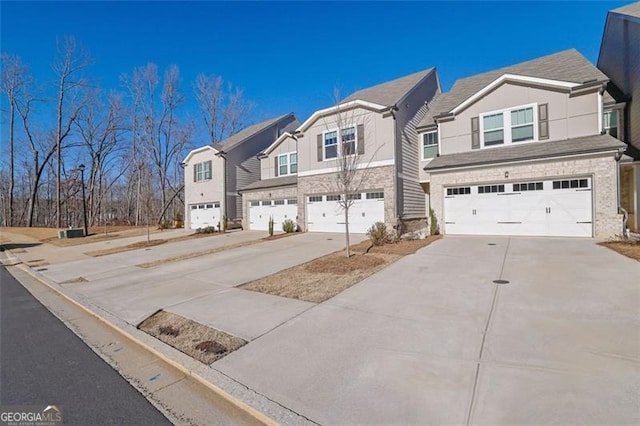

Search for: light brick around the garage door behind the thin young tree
xmin=298 ymin=166 xmax=396 ymax=231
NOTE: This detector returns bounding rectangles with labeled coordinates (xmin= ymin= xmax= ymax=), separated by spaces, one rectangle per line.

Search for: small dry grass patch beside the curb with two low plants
xmin=138 ymin=311 xmax=247 ymax=365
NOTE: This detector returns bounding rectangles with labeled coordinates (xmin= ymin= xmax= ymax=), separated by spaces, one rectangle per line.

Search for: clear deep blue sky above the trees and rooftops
xmin=0 ymin=1 xmax=630 ymax=124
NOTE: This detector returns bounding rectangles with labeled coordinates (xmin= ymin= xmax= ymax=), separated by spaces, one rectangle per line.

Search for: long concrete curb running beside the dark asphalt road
xmin=1 ymin=249 xmax=288 ymax=426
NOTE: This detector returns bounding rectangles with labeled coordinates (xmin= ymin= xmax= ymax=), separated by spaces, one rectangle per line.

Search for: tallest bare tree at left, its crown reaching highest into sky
xmin=53 ymin=37 xmax=92 ymax=228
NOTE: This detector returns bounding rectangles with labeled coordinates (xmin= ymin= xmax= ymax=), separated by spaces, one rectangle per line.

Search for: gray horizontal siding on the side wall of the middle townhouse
xmin=396 ymin=71 xmax=440 ymax=218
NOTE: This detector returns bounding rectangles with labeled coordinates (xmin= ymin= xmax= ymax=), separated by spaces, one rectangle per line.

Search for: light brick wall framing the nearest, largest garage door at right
xmin=431 ymin=154 xmax=622 ymax=238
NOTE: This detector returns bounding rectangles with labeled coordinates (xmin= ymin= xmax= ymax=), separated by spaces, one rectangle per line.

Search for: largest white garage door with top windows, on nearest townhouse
xmin=444 ymin=178 xmax=593 ymax=237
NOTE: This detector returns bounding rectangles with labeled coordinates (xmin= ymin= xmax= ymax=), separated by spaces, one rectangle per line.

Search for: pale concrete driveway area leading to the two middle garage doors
xmin=42 ymin=231 xmax=365 ymax=328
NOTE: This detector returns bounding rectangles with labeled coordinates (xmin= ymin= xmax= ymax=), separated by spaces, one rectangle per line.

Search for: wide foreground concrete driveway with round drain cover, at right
xmin=212 ymin=237 xmax=640 ymax=424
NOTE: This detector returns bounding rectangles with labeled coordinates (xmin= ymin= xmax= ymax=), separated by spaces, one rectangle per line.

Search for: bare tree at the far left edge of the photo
xmin=1 ymin=53 xmax=28 ymax=226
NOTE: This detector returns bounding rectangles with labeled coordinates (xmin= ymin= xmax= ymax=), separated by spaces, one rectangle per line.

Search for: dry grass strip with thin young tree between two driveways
xmin=240 ymin=236 xmax=441 ymax=303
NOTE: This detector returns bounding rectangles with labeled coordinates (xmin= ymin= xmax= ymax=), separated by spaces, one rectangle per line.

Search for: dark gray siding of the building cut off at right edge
xmin=598 ymin=12 xmax=640 ymax=149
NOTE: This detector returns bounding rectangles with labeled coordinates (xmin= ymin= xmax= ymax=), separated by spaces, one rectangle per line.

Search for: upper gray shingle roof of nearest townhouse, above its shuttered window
xmin=418 ymin=49 xmax=608 ymax=127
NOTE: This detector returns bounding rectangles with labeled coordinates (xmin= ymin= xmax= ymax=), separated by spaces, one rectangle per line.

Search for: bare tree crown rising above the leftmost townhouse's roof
xmin=193 ymin=74 xmax=254 ymax=145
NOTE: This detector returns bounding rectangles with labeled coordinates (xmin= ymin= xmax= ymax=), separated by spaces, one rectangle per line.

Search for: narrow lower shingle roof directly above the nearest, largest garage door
xmin=424 ymin=135 xmax=627 ymax=171
